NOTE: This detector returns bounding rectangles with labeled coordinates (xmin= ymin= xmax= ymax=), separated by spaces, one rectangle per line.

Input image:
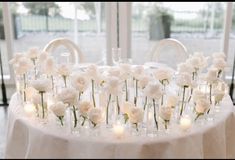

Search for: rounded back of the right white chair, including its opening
xmin=150 ymin=38 xmax=188 ymax=69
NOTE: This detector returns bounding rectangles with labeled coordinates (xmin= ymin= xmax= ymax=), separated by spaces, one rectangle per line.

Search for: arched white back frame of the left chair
xmin=43 ymin=38 xmax=83 ymax=64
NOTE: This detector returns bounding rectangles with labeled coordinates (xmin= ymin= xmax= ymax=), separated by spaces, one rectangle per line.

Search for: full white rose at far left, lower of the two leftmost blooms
xmin=14 ymin=57 xmax=33 ymax=75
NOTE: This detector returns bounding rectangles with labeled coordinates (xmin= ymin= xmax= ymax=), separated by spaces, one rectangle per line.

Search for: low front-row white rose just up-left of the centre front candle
xmin=88 ymin=108 xmax=103 ymax=124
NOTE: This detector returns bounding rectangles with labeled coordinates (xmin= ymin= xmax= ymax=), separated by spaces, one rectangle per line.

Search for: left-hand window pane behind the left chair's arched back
xmin=11 ymin=2 xmax=106 ymax=62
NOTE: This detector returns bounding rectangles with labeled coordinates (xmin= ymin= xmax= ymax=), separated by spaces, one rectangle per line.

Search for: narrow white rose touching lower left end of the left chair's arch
xmin=42 ymin=57 xmax=56 ymax=75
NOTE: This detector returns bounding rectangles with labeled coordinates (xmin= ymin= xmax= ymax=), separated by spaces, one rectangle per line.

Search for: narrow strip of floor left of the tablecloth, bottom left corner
xmin=0 ymin=106 xmax=7 ymax=159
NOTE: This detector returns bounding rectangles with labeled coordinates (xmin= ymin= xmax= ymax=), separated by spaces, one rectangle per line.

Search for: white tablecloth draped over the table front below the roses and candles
xmin=5 ymin=94 xmax=235 ymax=158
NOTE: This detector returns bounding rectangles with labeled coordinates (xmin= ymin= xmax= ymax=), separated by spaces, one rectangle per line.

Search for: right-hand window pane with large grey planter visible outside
xmin=132 ymin=2 xmax=225 ymax=64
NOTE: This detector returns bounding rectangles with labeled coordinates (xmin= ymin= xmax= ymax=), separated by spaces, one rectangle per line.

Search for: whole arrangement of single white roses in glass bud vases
xmin=9 ymin=48 xmax=227 ymax=136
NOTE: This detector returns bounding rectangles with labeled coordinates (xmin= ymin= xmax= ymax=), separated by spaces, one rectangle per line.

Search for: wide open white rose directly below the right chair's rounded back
xmin=153 ymin=68 xmax=173 ymax=82
